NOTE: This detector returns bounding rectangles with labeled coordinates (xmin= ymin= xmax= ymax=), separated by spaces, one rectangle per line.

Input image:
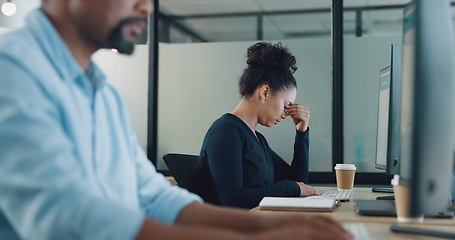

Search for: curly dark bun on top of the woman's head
xmin=246 ymin=42 xmax=297 ymax=73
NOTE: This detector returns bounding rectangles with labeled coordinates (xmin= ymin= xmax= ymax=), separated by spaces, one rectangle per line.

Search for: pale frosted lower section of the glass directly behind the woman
xmin=158 ymin=39 xmax=332 ymax=171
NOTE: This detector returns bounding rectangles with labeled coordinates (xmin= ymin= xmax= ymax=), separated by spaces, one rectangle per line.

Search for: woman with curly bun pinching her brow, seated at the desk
xmin=199 ymin=42 xmax=318 ymax=208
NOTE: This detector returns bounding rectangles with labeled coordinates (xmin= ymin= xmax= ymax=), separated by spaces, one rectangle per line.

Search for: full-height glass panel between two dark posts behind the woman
xmin=157 ymin=0 xmax=332 ymax=172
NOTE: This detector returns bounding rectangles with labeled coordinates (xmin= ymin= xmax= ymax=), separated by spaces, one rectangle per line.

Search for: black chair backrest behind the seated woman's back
xmin=163 ymin=153 xmax=199 ymax=194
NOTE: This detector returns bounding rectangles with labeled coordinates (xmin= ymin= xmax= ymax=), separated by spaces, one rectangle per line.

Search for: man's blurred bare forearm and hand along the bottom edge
xmin=136 ymin=203 xmax=352 ymax=240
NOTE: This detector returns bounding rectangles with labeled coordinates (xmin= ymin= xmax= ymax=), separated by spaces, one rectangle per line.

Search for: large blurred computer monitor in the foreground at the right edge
xmin=400 ymin=0 xmax=455 ymax=215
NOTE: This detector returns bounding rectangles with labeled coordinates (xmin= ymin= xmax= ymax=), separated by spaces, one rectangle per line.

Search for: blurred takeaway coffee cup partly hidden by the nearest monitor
xmin=392 ymin=175 xmax=423 ymax=222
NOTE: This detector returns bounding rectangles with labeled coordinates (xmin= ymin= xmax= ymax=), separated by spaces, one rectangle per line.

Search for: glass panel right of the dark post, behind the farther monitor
xmin=343 ymin=1 xmax=409 ymax=172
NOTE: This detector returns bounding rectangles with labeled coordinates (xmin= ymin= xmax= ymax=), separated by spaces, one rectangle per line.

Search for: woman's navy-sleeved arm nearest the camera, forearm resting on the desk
xmin=206 ymin=124 xmax=300 ymax=208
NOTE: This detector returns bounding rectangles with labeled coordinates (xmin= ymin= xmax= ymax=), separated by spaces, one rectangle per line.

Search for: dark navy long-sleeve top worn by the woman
xmin=198 ymin=113 xmax=309 ymax=208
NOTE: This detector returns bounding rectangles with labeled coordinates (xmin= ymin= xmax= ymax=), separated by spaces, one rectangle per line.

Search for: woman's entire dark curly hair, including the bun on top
xmin=239 ymin=42 xmax=297 ymax=97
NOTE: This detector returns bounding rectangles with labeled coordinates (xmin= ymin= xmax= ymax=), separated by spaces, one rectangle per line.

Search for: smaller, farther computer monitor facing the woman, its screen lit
xmin=375 ymin=45 xmax=401 ymax=175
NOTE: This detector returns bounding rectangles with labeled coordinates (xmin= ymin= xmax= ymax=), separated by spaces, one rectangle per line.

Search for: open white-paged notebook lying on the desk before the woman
xmin=259 ymin=196 xmax=340 ymax=212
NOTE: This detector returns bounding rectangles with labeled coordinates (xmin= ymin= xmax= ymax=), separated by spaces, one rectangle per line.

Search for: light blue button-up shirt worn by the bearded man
xmin=0 ymin=10 xmax=201 ymax=240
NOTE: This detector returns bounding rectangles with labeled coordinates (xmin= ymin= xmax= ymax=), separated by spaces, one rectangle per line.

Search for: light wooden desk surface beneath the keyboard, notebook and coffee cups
xmin=252 ymin=187 xmax=455 ymax=240
